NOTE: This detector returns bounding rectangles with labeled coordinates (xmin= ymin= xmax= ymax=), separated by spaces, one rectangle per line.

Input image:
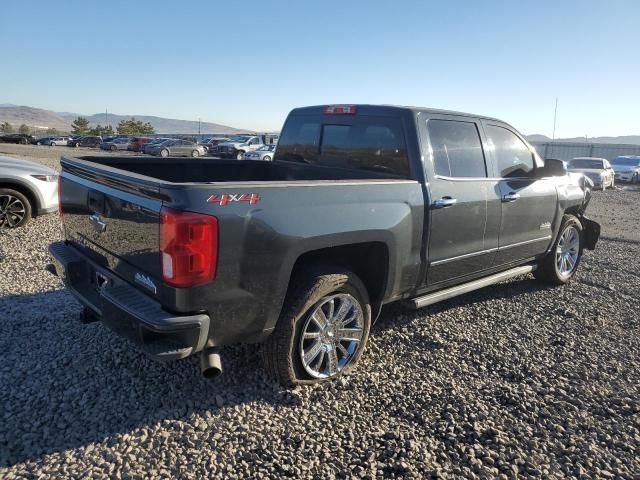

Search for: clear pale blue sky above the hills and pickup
xmin=0 ymin=0 xmax=640 ymax=137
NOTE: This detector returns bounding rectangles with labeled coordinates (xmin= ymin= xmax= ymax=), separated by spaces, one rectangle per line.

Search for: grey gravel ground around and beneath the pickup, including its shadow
xmin=0 ymin=148 xmax=640 ymax=478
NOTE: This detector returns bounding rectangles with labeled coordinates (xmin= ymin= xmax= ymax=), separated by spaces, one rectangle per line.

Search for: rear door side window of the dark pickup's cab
xmin=427 ymin=119 xmax=487 ymax=178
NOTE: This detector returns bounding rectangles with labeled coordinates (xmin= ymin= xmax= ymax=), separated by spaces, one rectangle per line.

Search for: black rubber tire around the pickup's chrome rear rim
xmin=262 ymin=267 xmax=371 ymax=387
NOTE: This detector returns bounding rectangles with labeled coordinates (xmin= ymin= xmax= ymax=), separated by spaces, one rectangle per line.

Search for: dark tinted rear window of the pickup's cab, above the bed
xmin=275 ymin=115 xmax=410 ymax=178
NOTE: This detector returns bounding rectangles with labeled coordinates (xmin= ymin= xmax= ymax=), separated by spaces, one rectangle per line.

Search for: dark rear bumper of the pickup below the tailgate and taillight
xmin=49 ymin=242 xmax=210 ymax=361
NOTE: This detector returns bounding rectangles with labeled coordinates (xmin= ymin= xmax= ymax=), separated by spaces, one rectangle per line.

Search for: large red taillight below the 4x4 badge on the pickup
xmin=160 ymin=207 xmax=218 ymax=287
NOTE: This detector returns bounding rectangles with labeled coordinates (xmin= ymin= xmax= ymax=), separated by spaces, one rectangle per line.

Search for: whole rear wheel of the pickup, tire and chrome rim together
xmin=262 ymin=267 xmax=371 ymax=387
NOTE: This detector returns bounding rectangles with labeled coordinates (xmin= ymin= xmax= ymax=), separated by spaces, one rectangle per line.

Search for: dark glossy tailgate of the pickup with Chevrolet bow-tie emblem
xmin=60 ymin=159 xmax=162 ymax=284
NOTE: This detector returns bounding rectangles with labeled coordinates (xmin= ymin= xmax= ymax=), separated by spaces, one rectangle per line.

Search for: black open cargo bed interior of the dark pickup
xmin=71 ymin=156 xmax=398 ymax=183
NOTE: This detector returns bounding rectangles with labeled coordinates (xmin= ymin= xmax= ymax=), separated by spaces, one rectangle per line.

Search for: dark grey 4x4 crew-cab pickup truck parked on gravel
xmin=49 ymin=105 xmax=600 ymax=386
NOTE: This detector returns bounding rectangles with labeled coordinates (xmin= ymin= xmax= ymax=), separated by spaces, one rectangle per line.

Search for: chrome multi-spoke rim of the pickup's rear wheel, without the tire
xmin=299 ymin=293 xmax=364 ymax=378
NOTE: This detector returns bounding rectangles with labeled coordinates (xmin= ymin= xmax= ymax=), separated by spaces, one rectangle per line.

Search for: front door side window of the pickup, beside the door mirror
xmin=486 ymin=125 xmax=535 ymax=178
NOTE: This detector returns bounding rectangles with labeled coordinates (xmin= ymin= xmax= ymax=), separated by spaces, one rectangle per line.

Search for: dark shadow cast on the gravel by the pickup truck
xmin=0 ymin=279 xmax=546 ymax=466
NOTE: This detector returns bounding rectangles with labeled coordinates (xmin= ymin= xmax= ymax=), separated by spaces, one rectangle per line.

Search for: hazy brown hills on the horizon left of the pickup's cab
xmin=0 ymin=104 xmax=251 ymax=134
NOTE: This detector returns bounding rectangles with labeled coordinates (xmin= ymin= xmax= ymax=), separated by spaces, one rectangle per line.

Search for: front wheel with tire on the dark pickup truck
xmin=533 ymin=215 xmax=584 ymax=285
